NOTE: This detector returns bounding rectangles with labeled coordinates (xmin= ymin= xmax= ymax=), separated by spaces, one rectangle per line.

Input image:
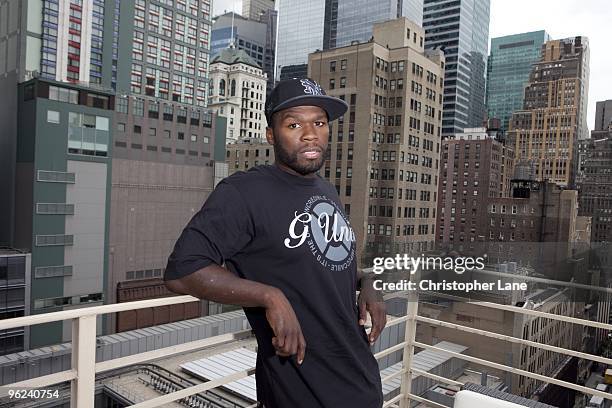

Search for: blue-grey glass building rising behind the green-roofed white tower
xmin=210 ymin=10 xmax=276 ymax=90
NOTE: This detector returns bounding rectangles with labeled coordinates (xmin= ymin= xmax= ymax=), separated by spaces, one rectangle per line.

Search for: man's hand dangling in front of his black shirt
xmin=265 ymin=290 xmax=306 ymax=364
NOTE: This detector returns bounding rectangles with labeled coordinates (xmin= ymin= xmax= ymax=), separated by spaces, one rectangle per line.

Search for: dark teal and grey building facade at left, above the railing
xmin=15 ymin=79 xmax=114 ymax=347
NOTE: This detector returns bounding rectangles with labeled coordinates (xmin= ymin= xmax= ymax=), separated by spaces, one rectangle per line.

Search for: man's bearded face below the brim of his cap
xmin=266 ymin=106 xmax=329 ymax=176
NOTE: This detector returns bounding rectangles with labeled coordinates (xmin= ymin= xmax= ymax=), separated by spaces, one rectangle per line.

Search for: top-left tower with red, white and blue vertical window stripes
xmin=0 ymin=0 xmax=123 ymax=244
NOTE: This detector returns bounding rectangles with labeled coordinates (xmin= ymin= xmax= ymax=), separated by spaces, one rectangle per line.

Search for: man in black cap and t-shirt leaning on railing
xmin=164 ymin=79 xmax=386 ymax=408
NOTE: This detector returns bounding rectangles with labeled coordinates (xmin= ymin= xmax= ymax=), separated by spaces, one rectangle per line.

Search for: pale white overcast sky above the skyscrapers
xmin=212 ymin=0 xmax=612 ymax=129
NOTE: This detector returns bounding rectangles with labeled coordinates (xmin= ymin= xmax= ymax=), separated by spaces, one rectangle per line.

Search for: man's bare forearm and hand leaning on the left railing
xmin=166 ymin=264 xmax=306 ymax=364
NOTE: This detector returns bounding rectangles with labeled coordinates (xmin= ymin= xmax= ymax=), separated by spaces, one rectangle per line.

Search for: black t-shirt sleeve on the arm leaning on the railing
xmin=164 ymin=181 xmax=254 ymax=280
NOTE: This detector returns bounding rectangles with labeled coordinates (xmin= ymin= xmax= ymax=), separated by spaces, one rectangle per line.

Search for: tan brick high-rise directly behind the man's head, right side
xmin=308 ymin=18 xmax=444 ymax=259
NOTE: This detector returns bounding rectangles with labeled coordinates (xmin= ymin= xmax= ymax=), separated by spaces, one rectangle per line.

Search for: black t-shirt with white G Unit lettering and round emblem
xmin=164 ymin=166 xmax=383 ymax=408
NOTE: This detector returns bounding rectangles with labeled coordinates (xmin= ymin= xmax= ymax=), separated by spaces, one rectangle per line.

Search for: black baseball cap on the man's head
xmin=266 ymin=78 xmax=348 ymax=126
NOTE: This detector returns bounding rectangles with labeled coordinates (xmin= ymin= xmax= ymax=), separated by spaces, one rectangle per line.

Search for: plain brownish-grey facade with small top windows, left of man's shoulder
xmin=106 ymin=96 xmax=226 ymax=332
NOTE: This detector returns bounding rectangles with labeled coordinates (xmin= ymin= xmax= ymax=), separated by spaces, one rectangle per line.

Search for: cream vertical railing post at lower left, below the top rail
xmin=70 ymin=315 xmax=96 ymax=408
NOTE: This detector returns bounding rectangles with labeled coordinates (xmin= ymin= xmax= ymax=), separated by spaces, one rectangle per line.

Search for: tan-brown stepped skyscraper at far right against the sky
xmin=508 ymin=37 xmax=589 ymax=186
